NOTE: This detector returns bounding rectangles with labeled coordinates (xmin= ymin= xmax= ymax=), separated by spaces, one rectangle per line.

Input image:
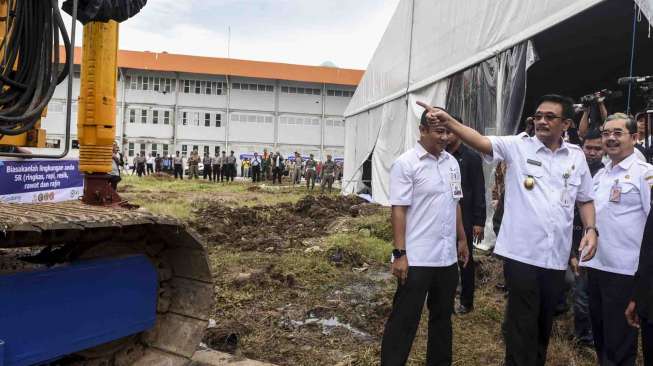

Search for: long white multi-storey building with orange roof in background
xmin=42 ymin=50 xmax=362 ymax=159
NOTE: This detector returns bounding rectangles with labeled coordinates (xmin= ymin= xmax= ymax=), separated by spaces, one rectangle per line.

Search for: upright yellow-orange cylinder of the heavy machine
xmin=77 ymin=21 xmax=118 ymax=174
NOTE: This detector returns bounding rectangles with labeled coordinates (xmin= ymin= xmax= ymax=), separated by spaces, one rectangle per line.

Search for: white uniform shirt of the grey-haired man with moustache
xmin=581 ymin=154 xmax=653 ymax=276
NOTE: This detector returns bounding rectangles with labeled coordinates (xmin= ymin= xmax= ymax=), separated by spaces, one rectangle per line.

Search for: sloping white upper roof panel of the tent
xmin=345 ymin=0 xmax=608 ymax=116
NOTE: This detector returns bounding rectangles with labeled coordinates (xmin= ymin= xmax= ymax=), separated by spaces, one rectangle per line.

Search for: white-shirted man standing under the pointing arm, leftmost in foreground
xmin=381 ymin=108 xmax=469 ymax=366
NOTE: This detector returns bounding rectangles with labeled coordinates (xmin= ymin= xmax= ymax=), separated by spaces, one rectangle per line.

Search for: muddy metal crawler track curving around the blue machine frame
xmin=0 ymin=202 xmax=213 ymax=366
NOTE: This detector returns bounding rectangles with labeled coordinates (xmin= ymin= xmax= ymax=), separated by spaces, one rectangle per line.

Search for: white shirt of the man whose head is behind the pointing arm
xmin=390 ymin=143 xmax=462 ymax=267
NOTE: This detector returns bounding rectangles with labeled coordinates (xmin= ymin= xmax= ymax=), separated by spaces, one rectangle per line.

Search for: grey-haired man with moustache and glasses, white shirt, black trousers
xmin=581 ymin=113 xmax=653 ymax=366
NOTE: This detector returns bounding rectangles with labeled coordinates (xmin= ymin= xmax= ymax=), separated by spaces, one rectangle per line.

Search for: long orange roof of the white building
xmin=62 ymin=47 xmax=364 ymax=86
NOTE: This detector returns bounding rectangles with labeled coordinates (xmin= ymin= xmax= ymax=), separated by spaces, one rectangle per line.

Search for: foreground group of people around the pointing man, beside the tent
xmin=381 ymin=95 xmax=653 ymax=366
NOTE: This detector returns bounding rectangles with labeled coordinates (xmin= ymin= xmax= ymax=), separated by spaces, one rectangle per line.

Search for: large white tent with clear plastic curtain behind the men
xmin=343 ymin=0 xmax=653 ymax=204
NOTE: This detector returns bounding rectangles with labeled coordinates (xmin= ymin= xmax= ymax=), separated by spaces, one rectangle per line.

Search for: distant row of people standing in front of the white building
xmin=114 ymin=144 xmax=343 ymax=192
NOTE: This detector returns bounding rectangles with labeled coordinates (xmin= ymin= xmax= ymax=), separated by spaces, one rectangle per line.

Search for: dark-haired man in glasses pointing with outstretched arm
xmin=418 ymin=95 xmax=597 ymax=366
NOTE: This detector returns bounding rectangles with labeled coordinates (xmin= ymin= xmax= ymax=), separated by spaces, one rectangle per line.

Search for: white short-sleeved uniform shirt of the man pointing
xmin=485 ymin=133 xmax=594 ymax=270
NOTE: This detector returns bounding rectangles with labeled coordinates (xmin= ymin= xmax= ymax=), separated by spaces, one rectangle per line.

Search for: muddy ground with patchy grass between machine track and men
xmin=119 ymin=176 xmax=628 ymax=366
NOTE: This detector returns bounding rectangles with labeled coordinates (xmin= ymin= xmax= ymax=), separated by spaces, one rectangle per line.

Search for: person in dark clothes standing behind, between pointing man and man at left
xmin=447 ymin=117 xmax=485 ymax=315
